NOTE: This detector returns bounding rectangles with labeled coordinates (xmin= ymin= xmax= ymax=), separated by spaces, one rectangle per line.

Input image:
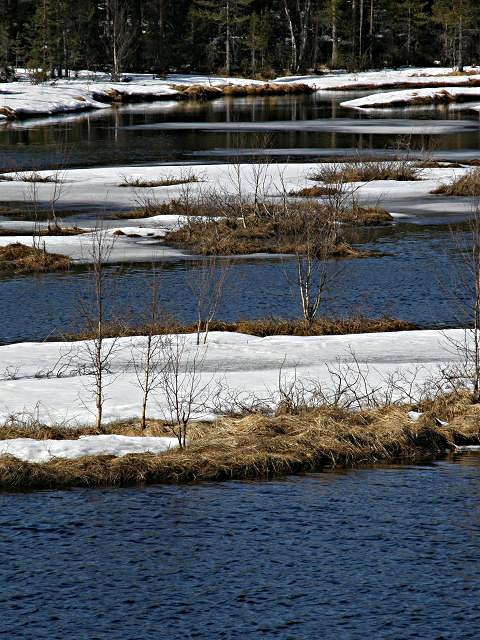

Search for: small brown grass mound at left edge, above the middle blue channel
xmin=0 ymin=242 xmax=72 ymax=274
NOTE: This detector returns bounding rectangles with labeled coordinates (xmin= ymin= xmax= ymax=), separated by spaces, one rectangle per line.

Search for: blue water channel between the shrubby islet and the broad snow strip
xmin=0 ymin=225 xmax=472 ymax=342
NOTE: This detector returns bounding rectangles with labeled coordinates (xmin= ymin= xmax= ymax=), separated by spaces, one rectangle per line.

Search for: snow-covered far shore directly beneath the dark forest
xmin=0 ymin=67 xmax=480 ymax=123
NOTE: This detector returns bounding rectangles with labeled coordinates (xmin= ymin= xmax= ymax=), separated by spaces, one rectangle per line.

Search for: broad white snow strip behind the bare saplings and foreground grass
xmin=0 ymin=329 xmax=465 ymax=426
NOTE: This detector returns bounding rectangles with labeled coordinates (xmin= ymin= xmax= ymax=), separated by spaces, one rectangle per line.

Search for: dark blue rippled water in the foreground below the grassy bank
xmin=0 ymin=454 xmax=480 ymax=640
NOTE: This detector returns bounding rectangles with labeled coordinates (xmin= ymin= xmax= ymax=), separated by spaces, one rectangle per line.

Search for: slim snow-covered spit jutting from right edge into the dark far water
xmin=340 ymin=86 xmax=480 ymax=109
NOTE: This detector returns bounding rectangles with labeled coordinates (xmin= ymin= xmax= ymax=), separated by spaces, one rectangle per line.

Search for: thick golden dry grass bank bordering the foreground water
xmin=0 ymin=404 xmax=480 ymax=490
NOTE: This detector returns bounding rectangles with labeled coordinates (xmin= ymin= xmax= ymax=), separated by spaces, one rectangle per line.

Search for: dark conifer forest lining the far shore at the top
xmin=0 ymin=0 xmax=480 ymax=80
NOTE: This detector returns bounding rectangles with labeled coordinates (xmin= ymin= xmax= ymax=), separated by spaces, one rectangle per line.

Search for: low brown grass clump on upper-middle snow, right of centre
xmin=308 ymin=160 xmax=419 ymax=184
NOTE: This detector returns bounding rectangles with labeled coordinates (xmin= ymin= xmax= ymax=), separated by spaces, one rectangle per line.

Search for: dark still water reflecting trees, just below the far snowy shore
xmin=0 ymin=92 xmax=480 ymax=167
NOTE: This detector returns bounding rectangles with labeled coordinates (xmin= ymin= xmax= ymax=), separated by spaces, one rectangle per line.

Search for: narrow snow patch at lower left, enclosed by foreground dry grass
xmin=0 ymin=435 xmax=178 ymax=462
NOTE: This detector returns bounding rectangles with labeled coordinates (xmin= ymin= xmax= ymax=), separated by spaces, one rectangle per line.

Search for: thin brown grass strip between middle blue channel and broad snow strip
xmin=59 ymin=315 xmax=418 ymax=341
